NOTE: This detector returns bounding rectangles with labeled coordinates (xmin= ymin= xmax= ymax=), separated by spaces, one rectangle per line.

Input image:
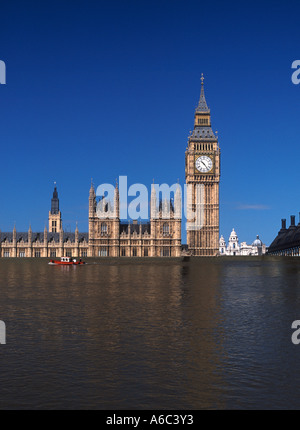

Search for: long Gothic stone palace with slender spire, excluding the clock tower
xmin=0 ymin=185 xmax=181 ymax=258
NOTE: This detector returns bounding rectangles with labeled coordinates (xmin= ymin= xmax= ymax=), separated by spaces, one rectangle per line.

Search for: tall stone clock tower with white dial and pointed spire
xmin=185 ymin=74 xmax=220 ymax=257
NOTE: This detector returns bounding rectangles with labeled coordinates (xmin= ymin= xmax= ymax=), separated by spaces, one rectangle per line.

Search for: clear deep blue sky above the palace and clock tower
xmin=0 ymin=0 xmax=300 ymax=244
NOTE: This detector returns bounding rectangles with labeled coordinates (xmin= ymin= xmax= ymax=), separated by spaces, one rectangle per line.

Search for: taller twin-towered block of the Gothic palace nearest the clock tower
xmin=88 ymin=181 xmax=181 ymax=257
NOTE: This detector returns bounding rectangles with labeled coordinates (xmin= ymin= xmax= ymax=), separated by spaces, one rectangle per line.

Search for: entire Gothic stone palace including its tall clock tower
xmin=0 ymin=75 xmax=220 ymax=258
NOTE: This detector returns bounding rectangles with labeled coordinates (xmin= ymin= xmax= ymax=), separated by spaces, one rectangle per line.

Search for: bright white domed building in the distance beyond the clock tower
xmin=219 ymin=229 xmax=266 ymax=256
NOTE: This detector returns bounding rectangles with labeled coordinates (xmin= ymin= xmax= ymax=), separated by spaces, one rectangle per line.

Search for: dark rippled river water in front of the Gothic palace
xmin=0 ymin=257 xmax=300 ymax=410
